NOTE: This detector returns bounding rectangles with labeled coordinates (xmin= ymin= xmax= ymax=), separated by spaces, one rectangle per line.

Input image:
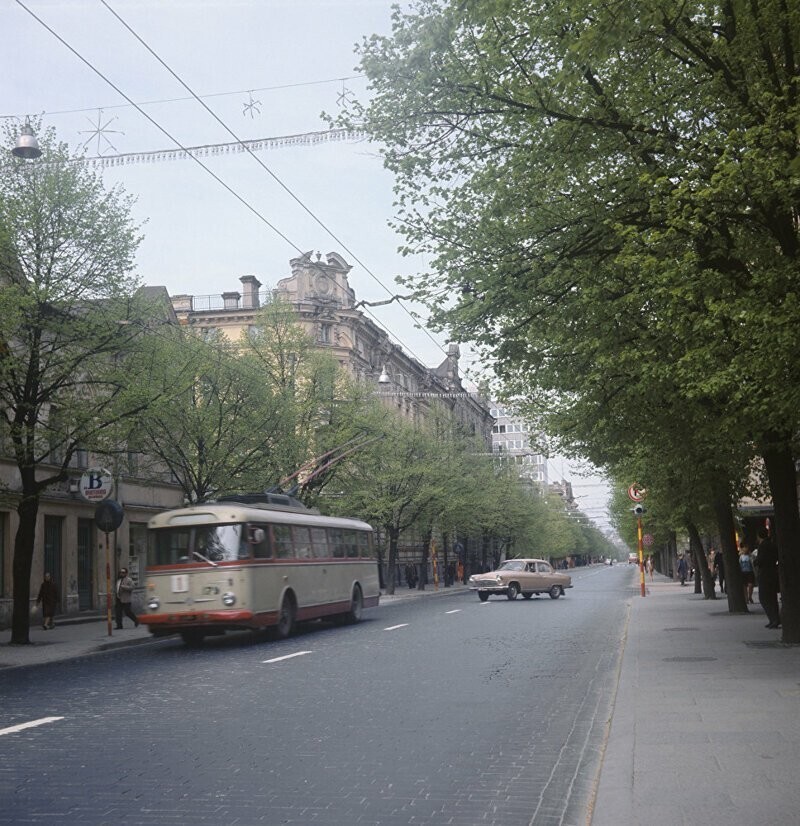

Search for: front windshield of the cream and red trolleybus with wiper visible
xmin=149 ymin=525 xmax=250 ymax=565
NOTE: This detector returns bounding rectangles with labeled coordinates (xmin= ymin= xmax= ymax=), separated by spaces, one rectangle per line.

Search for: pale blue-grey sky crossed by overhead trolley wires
xmin=0 ymin=0 xmax=606 ymax=536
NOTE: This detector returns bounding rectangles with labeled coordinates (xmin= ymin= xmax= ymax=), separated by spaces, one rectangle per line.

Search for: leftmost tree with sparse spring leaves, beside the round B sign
xmin=0 ymin=125 xmax=161 ymax=645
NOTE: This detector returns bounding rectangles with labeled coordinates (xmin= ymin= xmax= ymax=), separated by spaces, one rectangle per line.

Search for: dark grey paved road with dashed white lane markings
xmin=0 ymin=565 xmax=632 ymax=826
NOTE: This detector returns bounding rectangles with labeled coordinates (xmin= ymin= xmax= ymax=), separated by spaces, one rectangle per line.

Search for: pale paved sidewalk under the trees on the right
xmin=591 ymin=571 xmax=800 ymax=826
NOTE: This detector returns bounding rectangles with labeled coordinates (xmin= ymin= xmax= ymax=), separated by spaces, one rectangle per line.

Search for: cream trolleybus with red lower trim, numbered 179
xmin=139 ymin=494 xmax=380 ymax=644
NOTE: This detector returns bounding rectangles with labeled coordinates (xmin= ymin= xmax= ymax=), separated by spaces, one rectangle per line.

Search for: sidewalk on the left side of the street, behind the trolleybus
xmin=0 ymin=585 xmax=467 ymax=674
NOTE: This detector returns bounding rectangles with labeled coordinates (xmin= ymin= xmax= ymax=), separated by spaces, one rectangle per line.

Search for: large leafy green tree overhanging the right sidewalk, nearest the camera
xmin=353 ymin=0 xmax=800 ymax=642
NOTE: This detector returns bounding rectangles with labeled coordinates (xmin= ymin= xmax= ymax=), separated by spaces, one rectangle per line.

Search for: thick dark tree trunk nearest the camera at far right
xmin=761 ymin=442 xmax=800 ymax=645
